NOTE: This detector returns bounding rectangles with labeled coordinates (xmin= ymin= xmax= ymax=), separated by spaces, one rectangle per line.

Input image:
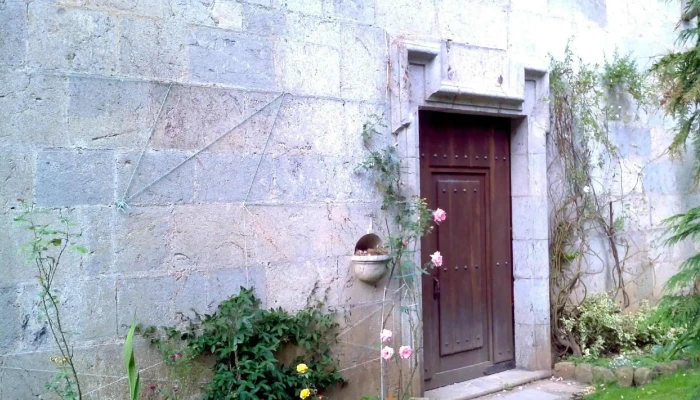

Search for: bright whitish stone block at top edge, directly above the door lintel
xmin=435 ymin=0 xmax=510 ymax=49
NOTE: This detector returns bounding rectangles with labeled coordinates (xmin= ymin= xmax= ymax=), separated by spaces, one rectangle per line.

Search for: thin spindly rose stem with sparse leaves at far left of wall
xmin=14 ymin=202 xmax=87 ymax=400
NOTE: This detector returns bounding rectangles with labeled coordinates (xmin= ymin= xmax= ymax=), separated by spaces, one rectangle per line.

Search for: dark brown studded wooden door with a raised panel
xmin=419 ymin=111 xmax=515 ymax=389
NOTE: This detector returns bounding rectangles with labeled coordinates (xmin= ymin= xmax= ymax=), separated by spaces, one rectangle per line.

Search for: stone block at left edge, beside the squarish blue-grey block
xmin=0 ymin=148 xmax=34 ymax=208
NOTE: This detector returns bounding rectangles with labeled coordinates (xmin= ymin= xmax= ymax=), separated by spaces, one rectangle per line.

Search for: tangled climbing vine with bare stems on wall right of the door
xmin=548 ymin=47 xmax=652 ymax=356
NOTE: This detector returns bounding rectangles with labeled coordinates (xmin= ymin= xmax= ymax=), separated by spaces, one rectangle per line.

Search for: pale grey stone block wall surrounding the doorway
xmin=0 ymin=0 xmax=695 ymax=398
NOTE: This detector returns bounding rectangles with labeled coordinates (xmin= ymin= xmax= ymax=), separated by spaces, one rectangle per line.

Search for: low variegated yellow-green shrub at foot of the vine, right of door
xmin=562 ymin=294 xmax=673 ymax=359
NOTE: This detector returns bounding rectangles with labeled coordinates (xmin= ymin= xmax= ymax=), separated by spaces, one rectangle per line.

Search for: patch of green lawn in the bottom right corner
xmin=584 ymin=369 xmax=700 ymax=400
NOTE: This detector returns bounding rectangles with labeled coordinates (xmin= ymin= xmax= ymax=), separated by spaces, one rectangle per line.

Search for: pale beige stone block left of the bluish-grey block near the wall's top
xmin=119 ymin=18 xmax=189 ymax=80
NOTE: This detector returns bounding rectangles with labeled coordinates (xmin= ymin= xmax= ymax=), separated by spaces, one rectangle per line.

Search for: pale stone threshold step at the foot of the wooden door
xmin=424 ymin=369 xmax=552 ymax=400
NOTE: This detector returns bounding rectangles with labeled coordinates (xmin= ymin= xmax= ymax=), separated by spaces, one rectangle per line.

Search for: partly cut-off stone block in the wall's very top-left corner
xmin=0 ymin=0 xmax=27 ymax=65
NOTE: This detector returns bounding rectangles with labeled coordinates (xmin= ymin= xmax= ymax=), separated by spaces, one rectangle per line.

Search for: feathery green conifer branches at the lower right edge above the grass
xmin=657 ymin=207 xmax=700 ymax=353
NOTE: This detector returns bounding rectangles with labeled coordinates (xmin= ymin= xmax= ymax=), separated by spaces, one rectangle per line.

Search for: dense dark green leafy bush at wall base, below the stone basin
xmin=145 ymin=288 xmax=344 ymax=400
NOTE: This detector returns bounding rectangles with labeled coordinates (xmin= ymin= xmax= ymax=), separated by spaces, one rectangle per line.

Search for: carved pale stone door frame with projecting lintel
xmin=389 ymin=39 xmax=552 ymax=393
